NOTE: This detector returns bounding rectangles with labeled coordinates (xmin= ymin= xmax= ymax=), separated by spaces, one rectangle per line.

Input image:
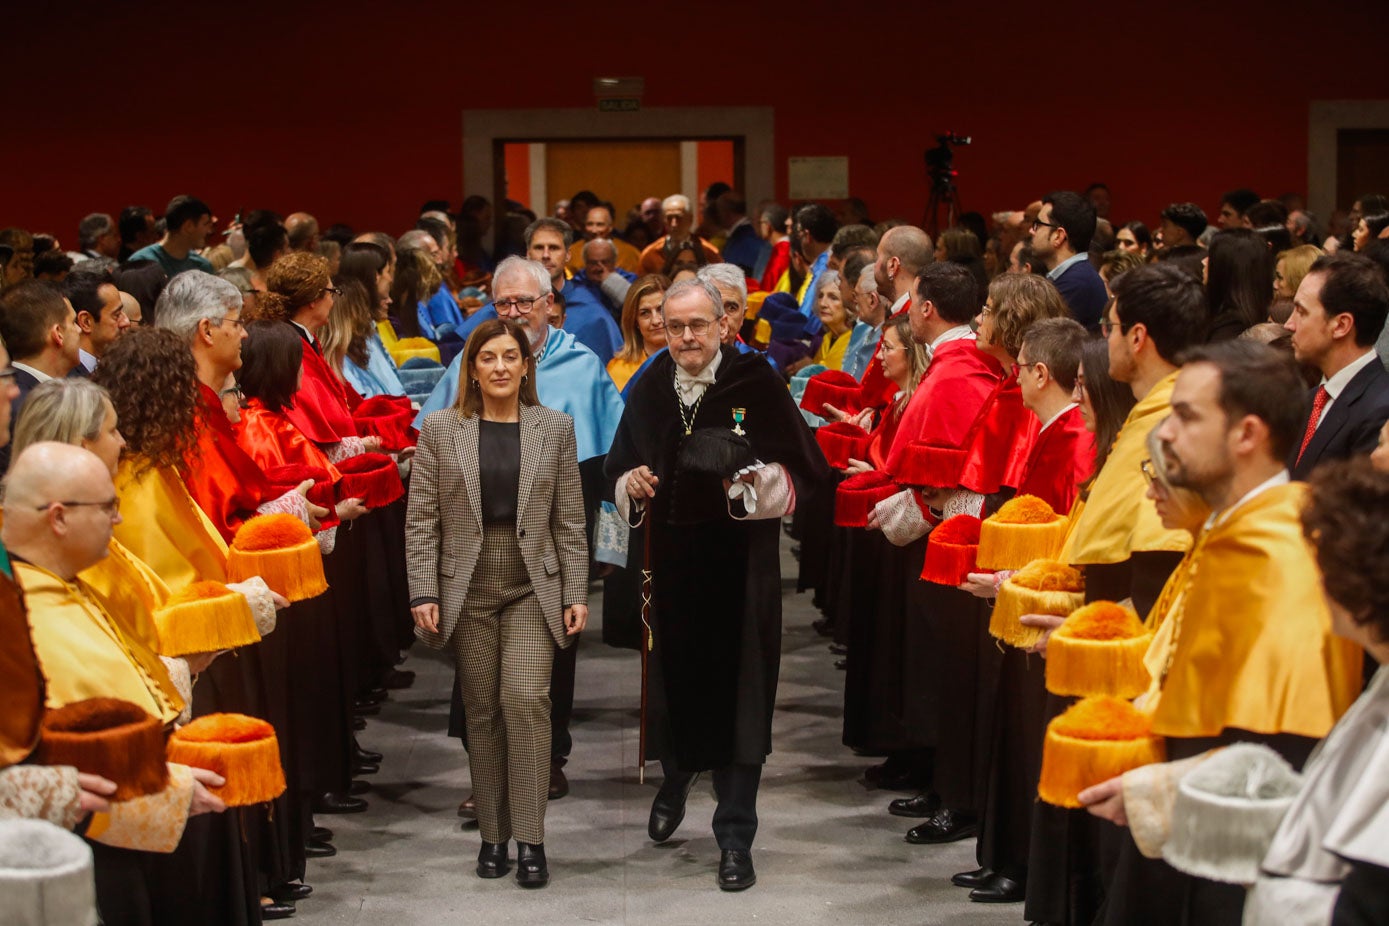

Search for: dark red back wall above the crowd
xmin=0 ymin=0 xmax=1389 ymax=238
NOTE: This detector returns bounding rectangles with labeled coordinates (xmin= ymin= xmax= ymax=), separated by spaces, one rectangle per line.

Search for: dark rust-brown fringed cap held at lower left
xmin=33 ymin=698 xmax=169 ymax=801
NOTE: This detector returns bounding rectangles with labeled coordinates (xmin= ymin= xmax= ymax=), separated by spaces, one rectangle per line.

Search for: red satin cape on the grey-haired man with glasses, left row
xmin=182 ymin=383 xmax=278 ymax=543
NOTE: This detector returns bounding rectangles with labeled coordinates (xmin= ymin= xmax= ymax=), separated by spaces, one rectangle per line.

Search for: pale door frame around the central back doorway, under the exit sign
xmin=463 ymin=106 xmax=776 ymax=230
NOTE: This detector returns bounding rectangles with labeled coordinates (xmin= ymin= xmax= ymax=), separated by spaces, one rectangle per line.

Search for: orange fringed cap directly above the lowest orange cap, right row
xmin=1046 ymin=601 xmax=1153 ymax=698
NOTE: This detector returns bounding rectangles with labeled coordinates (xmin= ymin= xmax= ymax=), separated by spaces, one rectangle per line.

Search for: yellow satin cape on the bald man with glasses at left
xmin=14 ymin=559 xmax=185 ymax=723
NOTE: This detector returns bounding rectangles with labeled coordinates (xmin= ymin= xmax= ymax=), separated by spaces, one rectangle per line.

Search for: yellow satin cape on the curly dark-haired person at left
xmin=115 ymin=460 xmax=226 ymax=589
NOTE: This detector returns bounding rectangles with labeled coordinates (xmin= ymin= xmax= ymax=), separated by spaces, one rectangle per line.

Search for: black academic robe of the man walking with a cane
xmin=606 ymin=347 xmax=829 ymax=772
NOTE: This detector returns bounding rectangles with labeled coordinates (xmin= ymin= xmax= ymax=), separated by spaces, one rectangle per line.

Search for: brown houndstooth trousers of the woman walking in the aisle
xmin=453 ymin=523 xmax=554 ymax=844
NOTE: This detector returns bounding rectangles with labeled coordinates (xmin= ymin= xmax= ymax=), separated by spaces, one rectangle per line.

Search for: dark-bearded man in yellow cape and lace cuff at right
xmin=1081 ymin=340 xmax=1360 ymax=926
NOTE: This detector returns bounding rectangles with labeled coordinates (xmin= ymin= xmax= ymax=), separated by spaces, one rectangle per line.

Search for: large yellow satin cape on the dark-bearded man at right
xmin=1150 ymin=483 xmax=1363 ymax=739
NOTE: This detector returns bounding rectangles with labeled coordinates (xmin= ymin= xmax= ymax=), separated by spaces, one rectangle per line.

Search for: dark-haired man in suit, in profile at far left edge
xmin=0 ymin=279 xmax=82 ymax=472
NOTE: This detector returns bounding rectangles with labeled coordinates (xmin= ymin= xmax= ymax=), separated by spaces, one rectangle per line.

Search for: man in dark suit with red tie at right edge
xmin=1285 ymin=254 xmax=1389 ymax=479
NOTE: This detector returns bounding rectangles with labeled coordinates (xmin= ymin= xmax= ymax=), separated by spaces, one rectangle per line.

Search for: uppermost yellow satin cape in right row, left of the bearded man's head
xmin=1061 ymin=372 xmax=1190 ymax=566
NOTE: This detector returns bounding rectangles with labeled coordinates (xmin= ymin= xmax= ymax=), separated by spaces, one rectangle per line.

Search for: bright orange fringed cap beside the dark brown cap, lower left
xmin=168 ymin=714 xmax=285 ymax=807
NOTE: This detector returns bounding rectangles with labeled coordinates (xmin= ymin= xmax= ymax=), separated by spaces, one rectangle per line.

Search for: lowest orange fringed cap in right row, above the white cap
xmin=1038 ymin=699 xmax=1165 ymax=808
